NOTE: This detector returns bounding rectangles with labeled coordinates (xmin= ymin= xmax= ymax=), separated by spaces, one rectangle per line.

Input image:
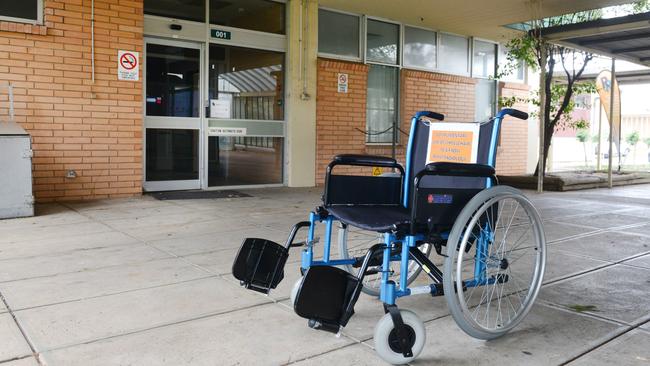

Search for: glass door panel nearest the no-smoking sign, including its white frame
xmin=144 ymin=39 xmax=203 ymax=191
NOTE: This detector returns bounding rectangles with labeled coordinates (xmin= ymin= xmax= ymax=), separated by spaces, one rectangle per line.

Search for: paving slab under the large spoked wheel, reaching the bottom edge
xmin=400 ymin=306 xmax=620 ymax=365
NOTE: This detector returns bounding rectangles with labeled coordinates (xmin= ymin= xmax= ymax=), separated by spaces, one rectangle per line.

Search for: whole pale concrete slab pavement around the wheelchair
xmin=0 ymin=185 xmax=650 ymax=366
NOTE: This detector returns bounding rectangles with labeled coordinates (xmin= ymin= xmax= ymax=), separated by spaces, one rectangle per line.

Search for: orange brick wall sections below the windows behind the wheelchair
xmin=316 ymin=63 xmax=528 ymax=184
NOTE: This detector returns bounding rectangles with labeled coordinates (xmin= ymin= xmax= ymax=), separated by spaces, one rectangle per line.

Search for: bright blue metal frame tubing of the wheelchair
xmin=301 ymin=109 xmax=518 ymax=305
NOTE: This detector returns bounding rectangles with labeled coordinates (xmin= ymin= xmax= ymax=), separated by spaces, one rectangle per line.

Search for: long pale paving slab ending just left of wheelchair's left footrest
xmin=0 ymin=258 xmax=209 ymax=310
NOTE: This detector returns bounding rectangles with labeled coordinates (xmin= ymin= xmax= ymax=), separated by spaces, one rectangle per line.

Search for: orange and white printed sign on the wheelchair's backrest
xmin=427 ymin=122 xmax=480 ymax=164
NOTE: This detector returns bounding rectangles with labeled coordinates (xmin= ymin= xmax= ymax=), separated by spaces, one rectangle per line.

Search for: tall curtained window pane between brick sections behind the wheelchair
xmin=366 ymin=64 xmax=399 ymax=143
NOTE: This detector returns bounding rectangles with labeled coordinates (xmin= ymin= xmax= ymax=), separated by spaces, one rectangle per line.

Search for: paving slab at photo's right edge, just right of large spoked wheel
xmin=539 ymin=265 xmax=650 ymax=323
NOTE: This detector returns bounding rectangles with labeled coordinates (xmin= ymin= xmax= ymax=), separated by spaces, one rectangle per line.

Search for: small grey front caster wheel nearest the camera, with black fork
xmin=374 ymin=310 xmax=427 ymax=365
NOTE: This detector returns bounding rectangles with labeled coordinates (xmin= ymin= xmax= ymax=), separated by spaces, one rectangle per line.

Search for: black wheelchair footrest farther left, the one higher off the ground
xmin=232 ymin=238 xmax=289 ymax=294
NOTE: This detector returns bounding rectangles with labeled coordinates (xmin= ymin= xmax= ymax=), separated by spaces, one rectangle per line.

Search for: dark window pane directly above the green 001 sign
xmin=210 ymin=0 xmax=285 ymax=34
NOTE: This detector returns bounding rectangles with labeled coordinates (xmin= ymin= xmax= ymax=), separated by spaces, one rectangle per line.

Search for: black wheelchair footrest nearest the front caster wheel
xmin=294 ymin=266 xmax=360 ymax=330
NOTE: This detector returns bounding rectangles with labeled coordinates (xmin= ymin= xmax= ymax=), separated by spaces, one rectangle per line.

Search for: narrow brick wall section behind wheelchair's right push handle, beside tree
xmin=497 ymin=82 xmax=530 ymax=175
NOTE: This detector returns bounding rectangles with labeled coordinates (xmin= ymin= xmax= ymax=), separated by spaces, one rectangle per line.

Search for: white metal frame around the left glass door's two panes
xmin=142 ymin=36 xmax=207 ymax=192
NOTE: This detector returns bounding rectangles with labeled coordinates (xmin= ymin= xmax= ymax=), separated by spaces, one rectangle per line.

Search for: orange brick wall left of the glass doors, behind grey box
xmin=0 ymin=0 xmax=143 ymax=202
